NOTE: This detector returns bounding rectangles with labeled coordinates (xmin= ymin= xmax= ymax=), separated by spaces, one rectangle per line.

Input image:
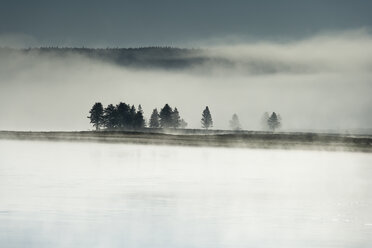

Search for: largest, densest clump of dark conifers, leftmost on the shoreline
xmin=88 ymin=102 xmax=145 ymax=130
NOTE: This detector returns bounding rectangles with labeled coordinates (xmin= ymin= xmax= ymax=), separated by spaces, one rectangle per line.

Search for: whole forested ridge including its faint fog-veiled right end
xmin=0 ymin=47 xmax=308 ymax=75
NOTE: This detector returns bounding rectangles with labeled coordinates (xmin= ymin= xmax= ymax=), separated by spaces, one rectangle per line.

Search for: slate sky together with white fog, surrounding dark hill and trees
xmin=0 ymin=0 xmax=372 ymax=133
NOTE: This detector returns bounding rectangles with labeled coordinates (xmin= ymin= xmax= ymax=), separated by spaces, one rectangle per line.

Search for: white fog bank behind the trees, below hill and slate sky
xmin=0 ymin=30 xmax=372 ymax=130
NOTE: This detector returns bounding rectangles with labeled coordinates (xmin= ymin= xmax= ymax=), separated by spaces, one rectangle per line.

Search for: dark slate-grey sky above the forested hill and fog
xmin=0 ymin=0 xmax=372 ymax=47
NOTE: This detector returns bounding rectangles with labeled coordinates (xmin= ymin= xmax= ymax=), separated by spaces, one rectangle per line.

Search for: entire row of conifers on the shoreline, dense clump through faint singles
xmin=88 ymin=102 xmax=281 ymax=131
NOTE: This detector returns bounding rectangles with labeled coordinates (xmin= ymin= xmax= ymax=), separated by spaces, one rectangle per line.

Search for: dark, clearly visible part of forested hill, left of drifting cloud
xmin=0 ymin=47 xmax=210 ymax=69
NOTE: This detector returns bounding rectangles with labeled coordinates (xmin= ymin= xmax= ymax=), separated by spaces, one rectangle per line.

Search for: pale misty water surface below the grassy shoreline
xmin=0 ymin=141 xmax=372 ymax=248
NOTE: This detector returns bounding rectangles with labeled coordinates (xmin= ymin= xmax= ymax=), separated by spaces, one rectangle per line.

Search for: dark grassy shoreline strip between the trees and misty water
xmin=0 ymin=130 xmax=372 ymax=152
